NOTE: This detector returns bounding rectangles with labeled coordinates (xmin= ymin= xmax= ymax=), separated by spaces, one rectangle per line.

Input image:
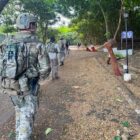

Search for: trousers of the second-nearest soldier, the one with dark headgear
xmin=50 ymin=59 xmax=58 ymax=79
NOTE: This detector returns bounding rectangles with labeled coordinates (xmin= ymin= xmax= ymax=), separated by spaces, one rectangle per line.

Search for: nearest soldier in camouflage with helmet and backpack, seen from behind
xmin=0 ymin=13 xmax=51 ymax=140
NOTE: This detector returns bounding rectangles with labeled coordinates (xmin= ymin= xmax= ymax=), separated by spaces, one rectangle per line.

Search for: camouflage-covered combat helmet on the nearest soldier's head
xmin=16 ymin=13 xmax=37 ymax=30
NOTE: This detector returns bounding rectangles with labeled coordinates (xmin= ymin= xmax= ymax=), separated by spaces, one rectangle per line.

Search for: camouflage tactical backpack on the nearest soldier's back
xmin=2 ymin=43 xmax=28 ymax=80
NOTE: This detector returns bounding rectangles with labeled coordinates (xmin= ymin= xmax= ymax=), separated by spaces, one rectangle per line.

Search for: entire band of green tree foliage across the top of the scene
xmin=0 ymin=0 xmax=140 ymax=44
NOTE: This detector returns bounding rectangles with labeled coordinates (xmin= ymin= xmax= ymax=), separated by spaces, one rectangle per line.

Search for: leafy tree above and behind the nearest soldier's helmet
xmin=2 ymin=0 xmax=69 ymax=43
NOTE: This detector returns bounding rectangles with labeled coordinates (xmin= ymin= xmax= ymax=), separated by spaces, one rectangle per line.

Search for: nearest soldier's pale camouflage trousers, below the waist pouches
xmin=11 ymin=95 xmax=37 ymax=140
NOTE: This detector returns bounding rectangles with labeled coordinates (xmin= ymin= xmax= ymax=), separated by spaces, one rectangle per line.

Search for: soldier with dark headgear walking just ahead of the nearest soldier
xmin=47 ymin=37 xmax=60 ymax=80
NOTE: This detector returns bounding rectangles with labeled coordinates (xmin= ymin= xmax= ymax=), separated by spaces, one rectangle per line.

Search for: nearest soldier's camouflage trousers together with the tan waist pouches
xmin=2 ymin=76 xmax=39 ymax=140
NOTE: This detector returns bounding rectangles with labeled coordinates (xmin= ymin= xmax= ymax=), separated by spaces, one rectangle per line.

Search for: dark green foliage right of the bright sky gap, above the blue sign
xmin=60 ymin=0 xmax=140 ymax=43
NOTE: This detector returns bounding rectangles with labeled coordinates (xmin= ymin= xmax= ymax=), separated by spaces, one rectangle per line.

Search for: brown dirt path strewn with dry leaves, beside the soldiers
xmin=0 ymin=48 xmax=140 ymax=140
